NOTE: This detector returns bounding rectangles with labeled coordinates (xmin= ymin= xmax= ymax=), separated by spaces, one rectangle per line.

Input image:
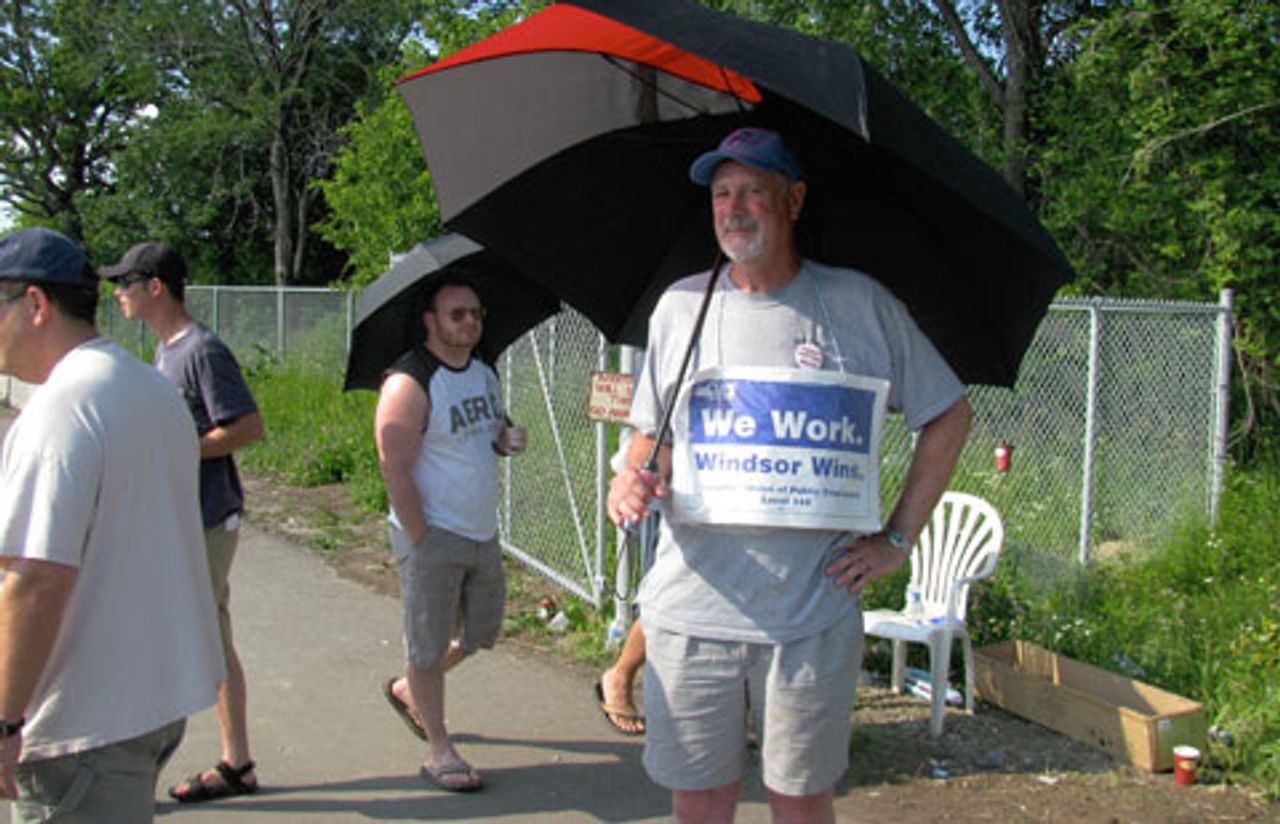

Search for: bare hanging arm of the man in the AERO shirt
xmin=374 ymin=374 xmax=431 ymax=544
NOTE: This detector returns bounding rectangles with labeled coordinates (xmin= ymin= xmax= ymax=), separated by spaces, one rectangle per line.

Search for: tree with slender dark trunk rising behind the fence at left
xmin=141 ymin=0 xmax=419 ymax=283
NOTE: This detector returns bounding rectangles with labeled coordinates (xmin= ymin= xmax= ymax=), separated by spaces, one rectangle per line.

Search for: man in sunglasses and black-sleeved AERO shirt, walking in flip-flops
xmin=374 ymin=275 xmax=525 ymax=792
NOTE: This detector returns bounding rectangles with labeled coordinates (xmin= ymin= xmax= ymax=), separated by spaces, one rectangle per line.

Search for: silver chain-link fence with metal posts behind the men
xmin=77 ymin=287 xmax=1231 ymax=606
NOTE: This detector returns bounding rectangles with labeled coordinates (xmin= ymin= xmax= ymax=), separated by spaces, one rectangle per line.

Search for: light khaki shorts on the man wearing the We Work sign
xmin=644 ymin=613 xmax=863 ymax=796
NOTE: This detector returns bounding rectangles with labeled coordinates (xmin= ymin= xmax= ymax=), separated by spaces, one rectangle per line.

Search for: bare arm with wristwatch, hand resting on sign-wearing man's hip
xmin=827 ymin=398 xmax=973 ymax=595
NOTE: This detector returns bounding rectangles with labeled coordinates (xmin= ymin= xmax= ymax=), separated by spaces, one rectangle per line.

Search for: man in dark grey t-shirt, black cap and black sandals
xmin=101 ymin=241 xmax=264 ymax=804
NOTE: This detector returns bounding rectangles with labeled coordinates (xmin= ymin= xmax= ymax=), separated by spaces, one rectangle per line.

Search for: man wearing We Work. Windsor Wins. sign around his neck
xmin=608 ymin=128 xmax=970 ymax=821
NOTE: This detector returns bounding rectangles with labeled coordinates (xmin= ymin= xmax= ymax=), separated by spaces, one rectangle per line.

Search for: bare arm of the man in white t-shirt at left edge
xmin=0 ymin=559 xmax=78 ymax=798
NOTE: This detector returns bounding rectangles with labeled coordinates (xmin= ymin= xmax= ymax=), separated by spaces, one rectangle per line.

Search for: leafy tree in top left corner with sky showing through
xmin=0 ymin=0 xmax=160 ymax=241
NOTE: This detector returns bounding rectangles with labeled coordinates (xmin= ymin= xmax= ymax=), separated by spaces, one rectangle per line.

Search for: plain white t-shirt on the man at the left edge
xmin=0 ymin=338 xmax=224 ymax=761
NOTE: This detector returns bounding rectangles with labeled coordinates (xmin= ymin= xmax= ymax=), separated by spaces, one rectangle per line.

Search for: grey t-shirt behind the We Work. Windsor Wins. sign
xmin=631 ymin=261 xmax=964 ymax=642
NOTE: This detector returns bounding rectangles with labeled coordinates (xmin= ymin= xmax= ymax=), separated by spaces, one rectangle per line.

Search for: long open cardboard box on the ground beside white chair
xmin=974 ymin=641 xmax=1204 ymax=773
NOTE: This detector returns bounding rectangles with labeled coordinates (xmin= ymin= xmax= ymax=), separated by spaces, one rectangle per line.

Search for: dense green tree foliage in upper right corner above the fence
xmin=1041 ymin=0 xmax=1280 ymax=452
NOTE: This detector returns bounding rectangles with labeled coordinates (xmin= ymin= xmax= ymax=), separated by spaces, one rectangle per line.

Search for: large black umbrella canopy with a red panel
xmin=399 ymin=0 xmax=1074 ymax=385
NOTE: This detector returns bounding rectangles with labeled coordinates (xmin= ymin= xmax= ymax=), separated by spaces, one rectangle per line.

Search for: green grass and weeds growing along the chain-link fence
xmin=244 ymin=358 xmax=1280 ymax=798
